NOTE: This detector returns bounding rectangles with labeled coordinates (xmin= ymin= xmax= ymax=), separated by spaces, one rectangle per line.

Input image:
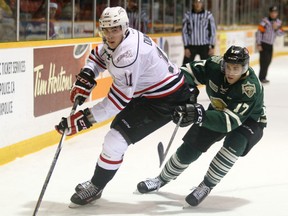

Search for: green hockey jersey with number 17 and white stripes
xmin=181 ymin=56 xmax=267 ymax=133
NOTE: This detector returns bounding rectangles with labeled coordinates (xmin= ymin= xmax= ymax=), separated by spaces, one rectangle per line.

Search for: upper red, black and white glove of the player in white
xmin=70 ymin=68 xmax=97 ymax=105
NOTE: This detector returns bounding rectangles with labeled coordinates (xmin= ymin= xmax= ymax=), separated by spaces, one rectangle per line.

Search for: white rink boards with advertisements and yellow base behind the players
xmin=0 ymin=29 xmax=288 ymax=165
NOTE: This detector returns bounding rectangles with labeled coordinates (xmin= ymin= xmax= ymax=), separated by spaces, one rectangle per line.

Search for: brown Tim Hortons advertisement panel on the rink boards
xmin=33 ymin=44 xmax=90 ymax=117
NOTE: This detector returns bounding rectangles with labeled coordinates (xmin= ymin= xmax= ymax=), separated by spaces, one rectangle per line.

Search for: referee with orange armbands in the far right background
xmin=256 ymin=6 xmax=284 ymax=83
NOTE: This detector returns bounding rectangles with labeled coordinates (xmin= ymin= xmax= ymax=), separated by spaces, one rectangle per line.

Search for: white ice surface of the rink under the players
xmin=0 ymin=56 xmax=288 ymax=216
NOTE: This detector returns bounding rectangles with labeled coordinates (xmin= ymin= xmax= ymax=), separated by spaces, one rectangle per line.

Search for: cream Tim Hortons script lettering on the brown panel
xmin=34 ymin=63 xmax=72 ymax=97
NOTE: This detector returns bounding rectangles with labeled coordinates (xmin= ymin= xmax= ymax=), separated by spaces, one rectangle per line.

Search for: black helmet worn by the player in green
xmin=223 ymin=46 xmax=250 ymax=74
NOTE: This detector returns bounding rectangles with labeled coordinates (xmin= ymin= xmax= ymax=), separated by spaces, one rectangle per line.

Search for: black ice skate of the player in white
xmin=69 ymin=181 xmax=103 ymax=208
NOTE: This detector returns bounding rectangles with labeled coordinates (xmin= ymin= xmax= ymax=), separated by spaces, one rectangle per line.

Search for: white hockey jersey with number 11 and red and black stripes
xmin=84 ymin=28 xmax=184 ymax=122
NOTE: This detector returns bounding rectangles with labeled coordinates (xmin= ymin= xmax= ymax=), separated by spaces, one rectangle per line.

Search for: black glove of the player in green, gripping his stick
xmin=172 ymin=103 xmax=205 ymax=127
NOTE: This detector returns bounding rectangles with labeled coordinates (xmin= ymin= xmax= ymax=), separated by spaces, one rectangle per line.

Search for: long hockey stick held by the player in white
xmin=33 ymin=100 xmax=78 ymax=216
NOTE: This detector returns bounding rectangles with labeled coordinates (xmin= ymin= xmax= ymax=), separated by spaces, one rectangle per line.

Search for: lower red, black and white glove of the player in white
xmin=55 ymin=108 xmax=92 ymax=136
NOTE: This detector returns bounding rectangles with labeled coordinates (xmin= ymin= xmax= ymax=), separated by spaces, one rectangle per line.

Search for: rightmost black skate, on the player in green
xmin=185 ymin=182 xmax=211 ymax=206
